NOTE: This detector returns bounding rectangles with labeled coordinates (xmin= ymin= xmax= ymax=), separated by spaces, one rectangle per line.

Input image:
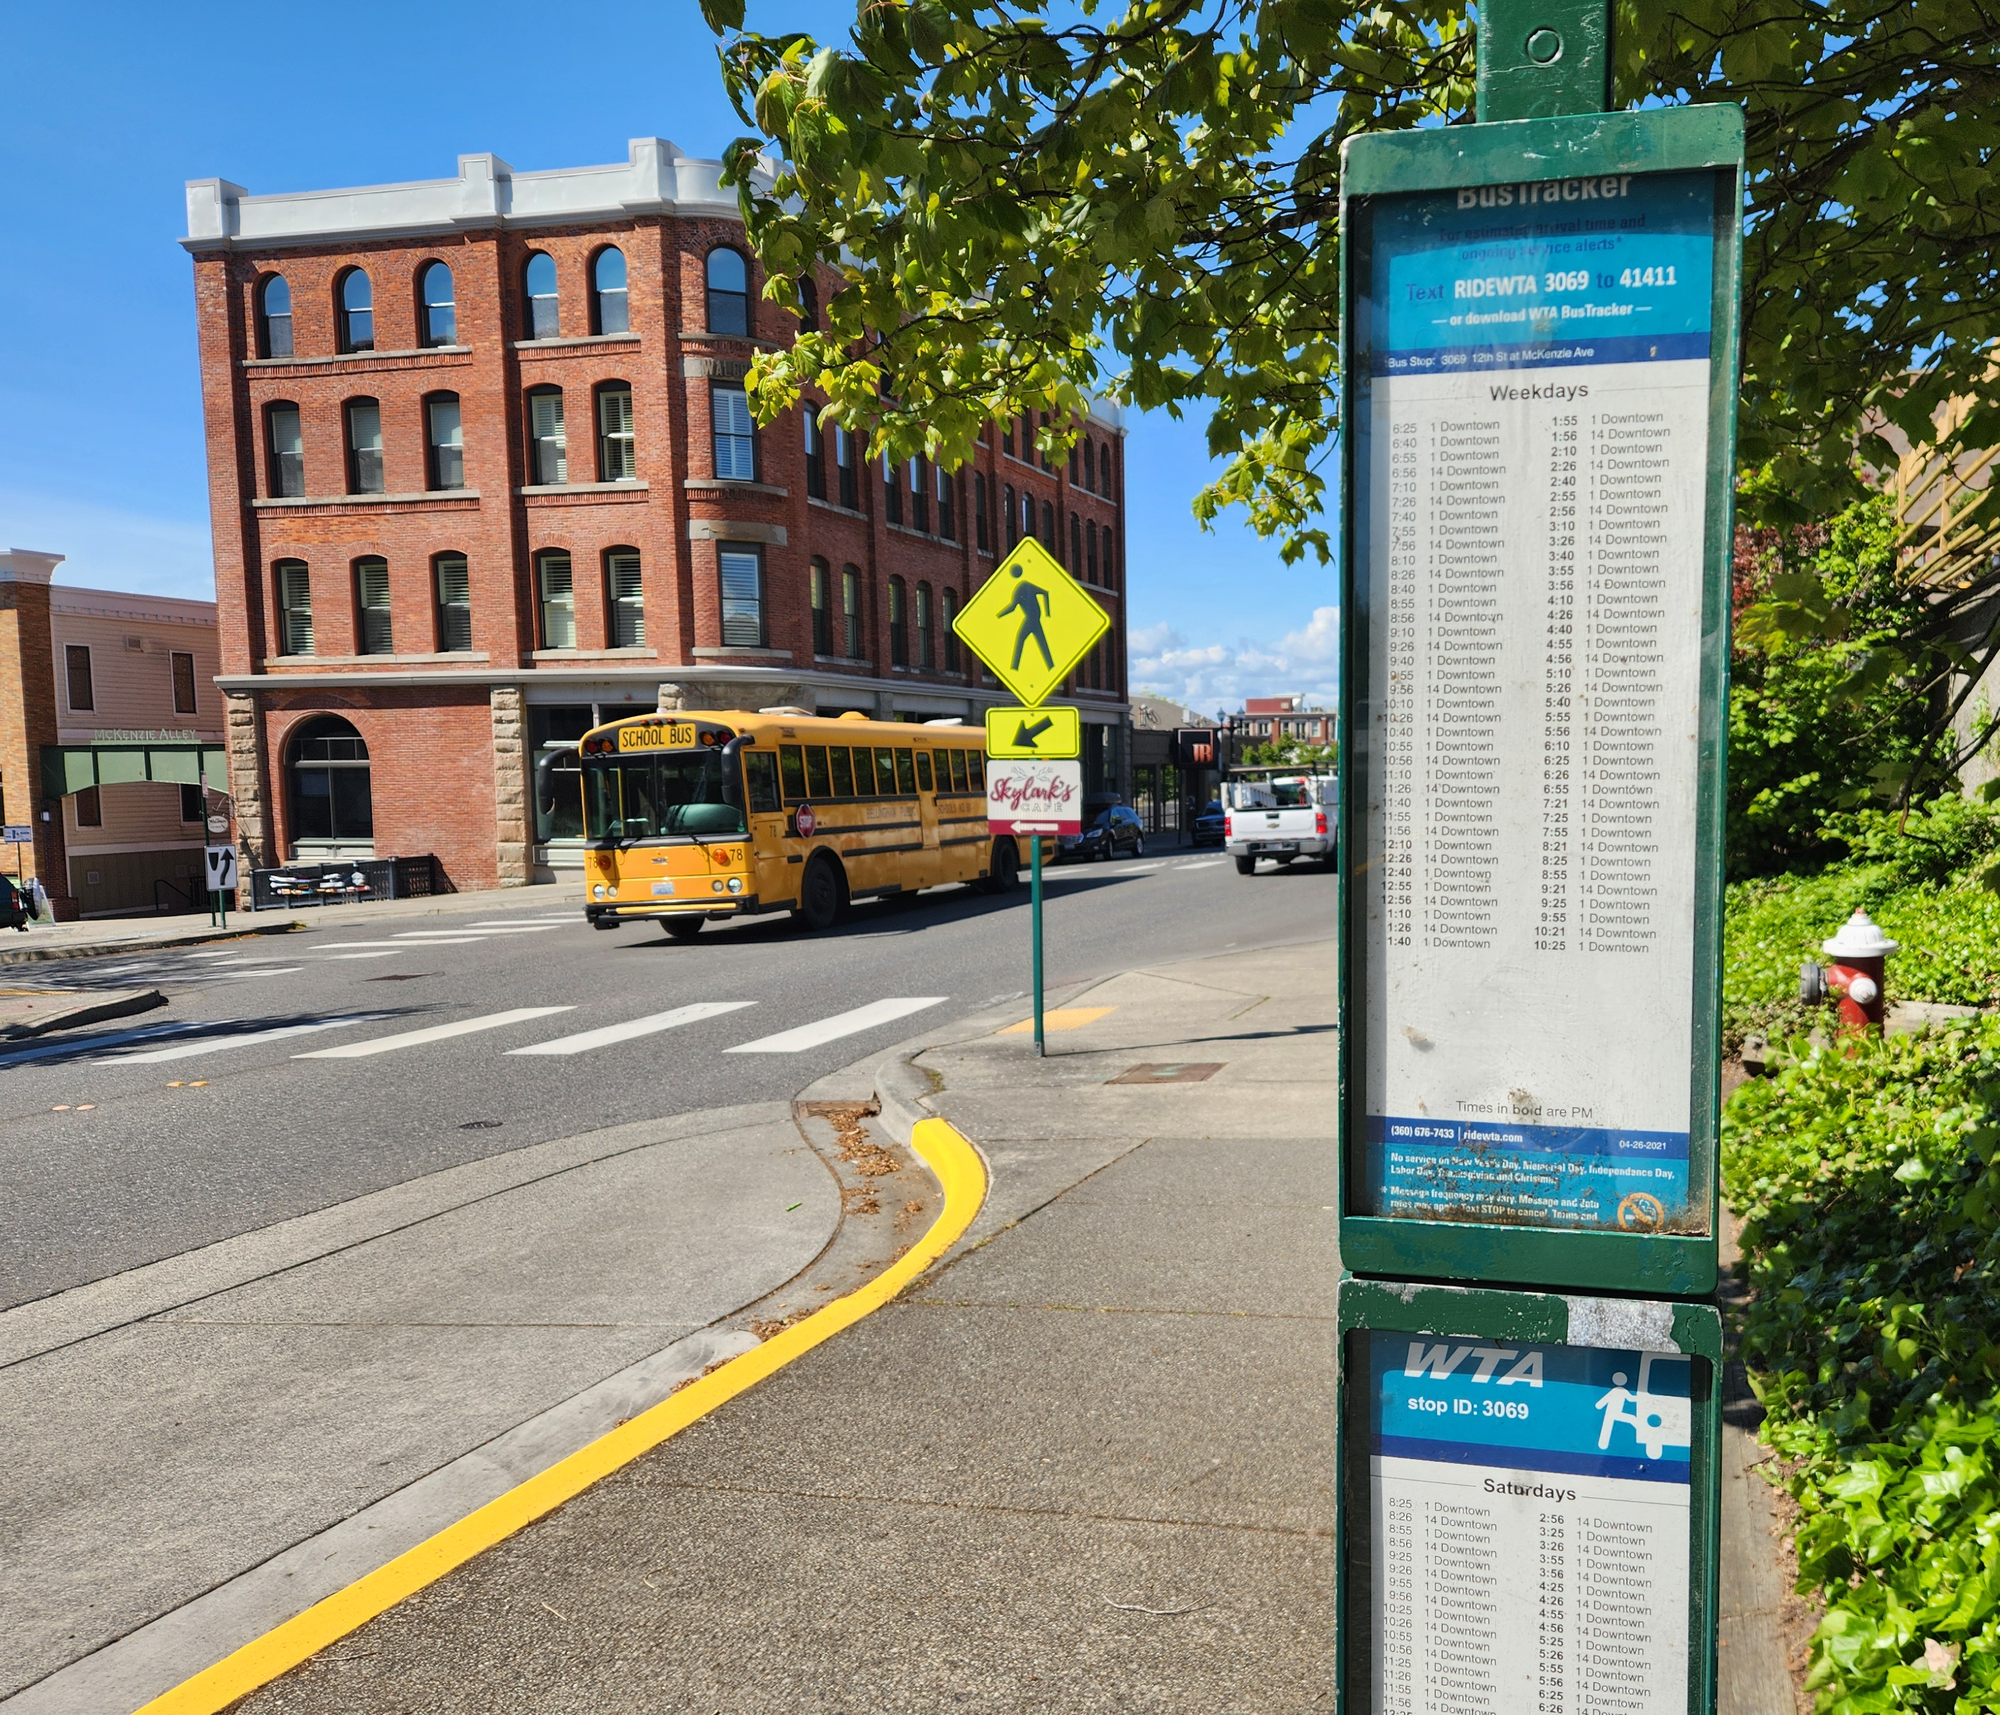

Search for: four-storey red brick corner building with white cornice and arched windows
xmin=182 ymin=138 xmax=1126 ymax=887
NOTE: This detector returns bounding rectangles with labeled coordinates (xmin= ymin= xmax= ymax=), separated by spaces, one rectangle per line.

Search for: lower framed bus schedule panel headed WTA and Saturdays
xmin=1342 ymin=1283 xmax=1720 ymax=1715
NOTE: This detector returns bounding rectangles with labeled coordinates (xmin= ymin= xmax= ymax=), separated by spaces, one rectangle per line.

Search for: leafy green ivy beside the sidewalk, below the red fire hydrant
xmin=1722 ymin=1023 xmax=2000 ymax=1715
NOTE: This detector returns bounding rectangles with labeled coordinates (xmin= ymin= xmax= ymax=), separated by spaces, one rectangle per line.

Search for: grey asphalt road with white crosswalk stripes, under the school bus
xmin=0 ymin=850 xmax=1334 ymax=1309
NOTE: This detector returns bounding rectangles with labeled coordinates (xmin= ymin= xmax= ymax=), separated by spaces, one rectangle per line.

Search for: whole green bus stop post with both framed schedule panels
xmin=1338 ymin=0 xmax=1744 ymax=1715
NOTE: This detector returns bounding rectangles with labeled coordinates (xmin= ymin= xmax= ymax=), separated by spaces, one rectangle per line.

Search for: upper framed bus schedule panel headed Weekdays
xmin=1342 ymin=100 xmax=1740 ymax=1291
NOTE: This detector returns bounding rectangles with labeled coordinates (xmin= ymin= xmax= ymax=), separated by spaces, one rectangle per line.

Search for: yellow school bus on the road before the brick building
xmin=578 ymin=710 xmax=1020 ymax=939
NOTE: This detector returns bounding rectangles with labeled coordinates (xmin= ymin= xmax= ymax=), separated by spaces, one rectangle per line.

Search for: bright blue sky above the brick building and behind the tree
xmin=0 ymin=0 xmax=1336 ymax=710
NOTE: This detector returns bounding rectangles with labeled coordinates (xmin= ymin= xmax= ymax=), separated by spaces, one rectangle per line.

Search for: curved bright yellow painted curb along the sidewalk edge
xmin=136 ymin=1119 xmax=986 ymax=1715
